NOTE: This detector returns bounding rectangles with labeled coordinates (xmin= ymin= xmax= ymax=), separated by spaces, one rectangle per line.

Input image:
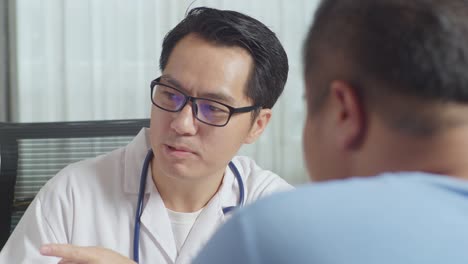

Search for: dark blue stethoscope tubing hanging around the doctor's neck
xmin=133 ymin=149 xmax=245 ymax=263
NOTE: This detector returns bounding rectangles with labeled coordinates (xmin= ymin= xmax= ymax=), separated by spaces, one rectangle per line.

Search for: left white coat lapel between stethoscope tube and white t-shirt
xmin=140 ymin=179 xmax=177 ymax=262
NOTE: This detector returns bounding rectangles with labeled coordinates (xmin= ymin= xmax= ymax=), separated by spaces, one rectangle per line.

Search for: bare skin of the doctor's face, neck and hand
xmin=40 ymin=34 xmax=271 ymax=264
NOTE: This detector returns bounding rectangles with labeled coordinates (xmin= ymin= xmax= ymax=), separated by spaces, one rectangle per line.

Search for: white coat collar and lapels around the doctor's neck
xmin=120 ymin=128 xmax=247 ymax=263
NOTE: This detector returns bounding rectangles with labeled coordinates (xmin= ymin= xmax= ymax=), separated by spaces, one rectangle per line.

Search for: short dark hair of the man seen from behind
xmin=304 ymin=0 xmax=468 ymax=135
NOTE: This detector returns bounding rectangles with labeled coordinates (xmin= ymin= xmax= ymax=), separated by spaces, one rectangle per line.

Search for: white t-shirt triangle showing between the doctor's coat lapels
xmin=167 ymin=208 xmax=203 ymax=254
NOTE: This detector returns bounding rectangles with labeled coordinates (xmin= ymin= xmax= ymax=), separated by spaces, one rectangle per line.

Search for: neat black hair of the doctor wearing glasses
xmin=159 ymin=7 xmax=288 ymax=111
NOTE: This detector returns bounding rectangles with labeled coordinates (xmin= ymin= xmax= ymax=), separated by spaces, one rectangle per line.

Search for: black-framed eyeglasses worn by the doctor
xmin=151 ymin=77 xmax=260 ymax=127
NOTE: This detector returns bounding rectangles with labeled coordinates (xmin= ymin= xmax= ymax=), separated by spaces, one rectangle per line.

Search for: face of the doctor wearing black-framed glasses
xmin=150 ymin=34 xmax=269 ymax=184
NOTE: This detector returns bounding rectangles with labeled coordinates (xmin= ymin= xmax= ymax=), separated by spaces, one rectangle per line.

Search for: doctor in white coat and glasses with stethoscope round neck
xmin=0 ymin=8 xmax=291 ymax=263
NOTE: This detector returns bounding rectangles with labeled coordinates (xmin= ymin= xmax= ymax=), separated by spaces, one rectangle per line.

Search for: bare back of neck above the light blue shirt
xmin=356 ymin=118 xmax=468 ymax=179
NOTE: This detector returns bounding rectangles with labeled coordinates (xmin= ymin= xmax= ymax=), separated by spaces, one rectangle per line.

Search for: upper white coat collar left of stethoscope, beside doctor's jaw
xmin=123 ymin=128 xmax=151 ymax=194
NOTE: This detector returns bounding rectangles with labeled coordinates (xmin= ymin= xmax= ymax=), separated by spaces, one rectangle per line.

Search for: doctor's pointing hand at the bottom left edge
xmin=40 ymin=244 xmax=135 ymax=264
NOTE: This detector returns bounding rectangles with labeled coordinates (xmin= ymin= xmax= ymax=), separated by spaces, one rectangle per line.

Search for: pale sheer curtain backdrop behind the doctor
xmin=0 ymin=0 xmax=318 ymax=184
